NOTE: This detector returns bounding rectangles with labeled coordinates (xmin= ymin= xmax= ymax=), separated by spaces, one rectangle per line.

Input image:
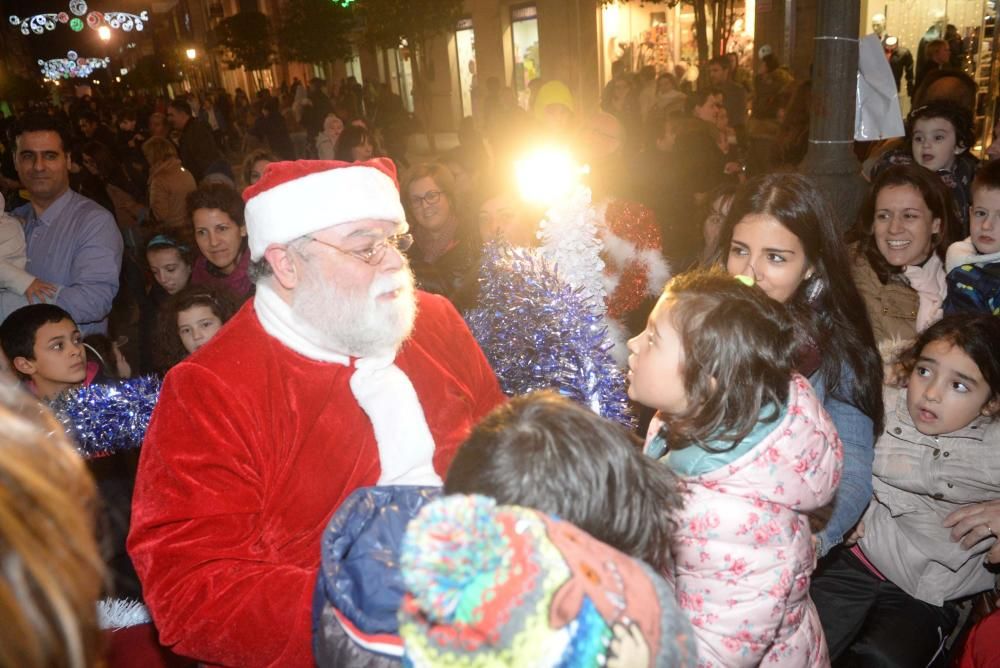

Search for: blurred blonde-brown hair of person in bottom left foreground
xmin=0 ymin=384 xmax=105 ymax=668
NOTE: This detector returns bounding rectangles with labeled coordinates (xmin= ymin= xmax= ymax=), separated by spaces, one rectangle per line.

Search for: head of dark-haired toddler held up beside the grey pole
xmin=906 ymin=100 xmax=975 ymax=172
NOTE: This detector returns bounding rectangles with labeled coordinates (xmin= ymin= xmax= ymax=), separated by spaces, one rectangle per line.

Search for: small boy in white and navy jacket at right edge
xmin=944 ymin=162 xmax=1000 ymax=315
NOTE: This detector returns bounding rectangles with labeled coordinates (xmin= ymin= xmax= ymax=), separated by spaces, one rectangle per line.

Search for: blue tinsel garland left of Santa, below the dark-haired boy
xmin=51 ymin=376 xmax=162 ymax=459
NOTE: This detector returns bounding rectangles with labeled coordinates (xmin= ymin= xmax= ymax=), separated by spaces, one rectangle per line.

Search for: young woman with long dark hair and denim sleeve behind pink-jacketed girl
xmin=718 ymin=174 xmax=884 ymax=555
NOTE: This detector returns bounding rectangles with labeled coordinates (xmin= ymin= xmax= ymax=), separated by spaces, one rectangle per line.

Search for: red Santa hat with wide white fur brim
xmin=243 ymin=158 xmax=406 ymax=260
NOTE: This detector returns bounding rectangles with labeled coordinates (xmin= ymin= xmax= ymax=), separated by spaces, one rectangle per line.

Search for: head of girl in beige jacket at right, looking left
xmin=900 ymin=313 xmax=1000 ymax=436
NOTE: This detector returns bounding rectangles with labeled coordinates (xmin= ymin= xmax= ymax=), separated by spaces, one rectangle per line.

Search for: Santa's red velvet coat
xmin=128 ymin=293 xmax=504 ymax=666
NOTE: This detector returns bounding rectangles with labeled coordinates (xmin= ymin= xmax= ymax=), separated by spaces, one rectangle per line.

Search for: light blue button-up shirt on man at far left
xmin=12 ymin=190 xmax=123 ymax=336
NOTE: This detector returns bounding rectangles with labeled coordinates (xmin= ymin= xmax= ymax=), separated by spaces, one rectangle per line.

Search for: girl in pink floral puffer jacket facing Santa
xmin=629 ymin=272 xmax=843 ymax=668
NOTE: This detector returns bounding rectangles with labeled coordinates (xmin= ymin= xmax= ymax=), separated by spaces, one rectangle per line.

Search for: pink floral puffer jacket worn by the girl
xmin=673 ymin=376 xmax=843 ymax=668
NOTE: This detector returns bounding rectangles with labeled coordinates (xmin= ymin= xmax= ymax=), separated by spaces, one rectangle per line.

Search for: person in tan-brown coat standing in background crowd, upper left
xmin=142 ymin=137 xmax=198 ymax=247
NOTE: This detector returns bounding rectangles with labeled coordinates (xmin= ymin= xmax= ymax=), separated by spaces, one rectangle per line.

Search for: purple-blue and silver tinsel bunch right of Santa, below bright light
xmin=465 ymin=243 xmax=635 ymax=428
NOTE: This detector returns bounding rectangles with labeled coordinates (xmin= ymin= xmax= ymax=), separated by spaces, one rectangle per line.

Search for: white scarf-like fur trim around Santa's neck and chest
xmin=254 ymin=282 xmax=442 ymax=485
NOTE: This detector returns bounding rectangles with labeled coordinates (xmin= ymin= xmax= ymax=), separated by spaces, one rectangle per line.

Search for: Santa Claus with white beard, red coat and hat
xmin=128 ymin=160 xmax=503 ymax=666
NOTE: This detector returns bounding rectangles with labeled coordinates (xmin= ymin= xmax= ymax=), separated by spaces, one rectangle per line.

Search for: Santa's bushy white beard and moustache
xmin=292 ymin=263 xmax=417 ymax=357
